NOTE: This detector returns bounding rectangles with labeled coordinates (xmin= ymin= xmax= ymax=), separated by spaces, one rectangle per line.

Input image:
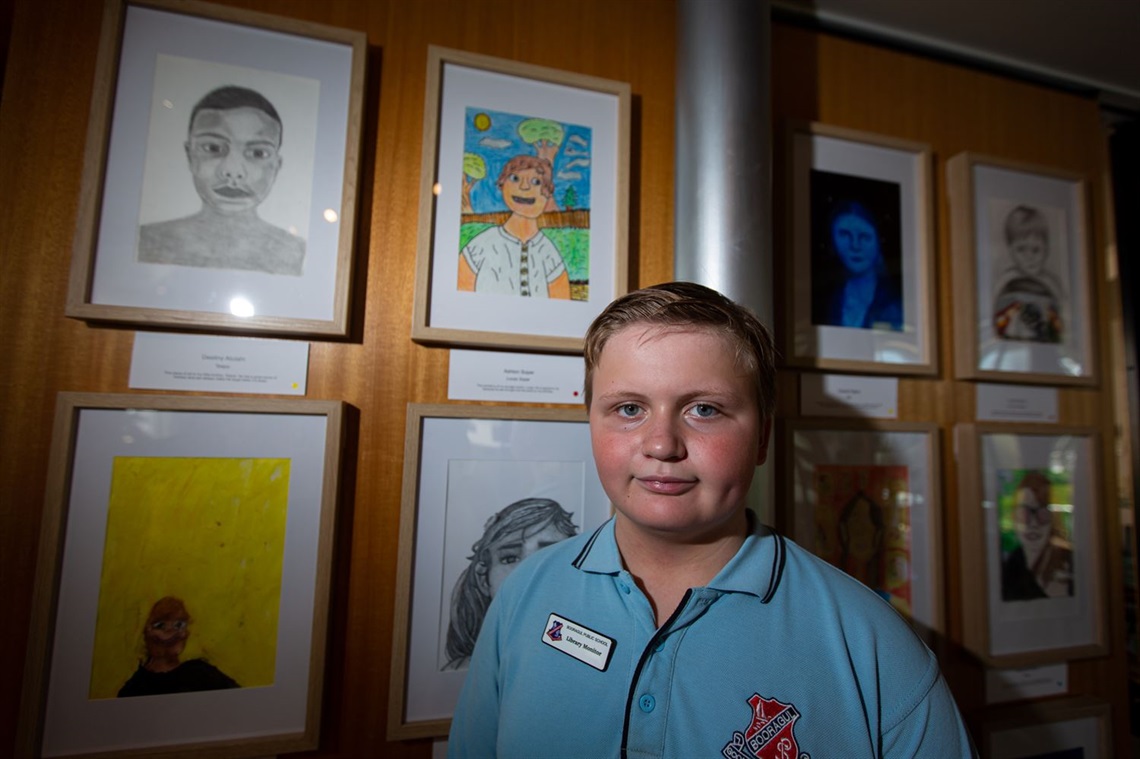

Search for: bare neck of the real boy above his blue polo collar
xmin=614 ymin=512 xmax=748 ymax=627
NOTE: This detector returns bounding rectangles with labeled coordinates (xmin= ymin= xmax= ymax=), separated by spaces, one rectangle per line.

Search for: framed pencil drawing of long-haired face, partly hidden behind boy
xmin=388 ymin=403 xmax=610 ymax=740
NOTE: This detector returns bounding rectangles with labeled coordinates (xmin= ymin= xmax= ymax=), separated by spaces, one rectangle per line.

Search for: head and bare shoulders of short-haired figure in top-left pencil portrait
xmin=139 ymin=87 xmax=304 ymax=277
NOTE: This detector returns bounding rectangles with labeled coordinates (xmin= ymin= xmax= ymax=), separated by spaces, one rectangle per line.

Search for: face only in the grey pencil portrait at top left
xmin=186 ymin=106 xmax=282 ymax=213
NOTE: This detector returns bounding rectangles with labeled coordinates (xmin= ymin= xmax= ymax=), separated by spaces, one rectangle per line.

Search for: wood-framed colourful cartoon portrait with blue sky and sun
xmin=412 ymin=47 xmax=629 ymax=352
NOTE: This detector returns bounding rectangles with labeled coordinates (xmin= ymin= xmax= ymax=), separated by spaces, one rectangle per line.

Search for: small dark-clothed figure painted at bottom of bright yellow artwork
xmin=119 ymin=596 xmax=241 ymax=699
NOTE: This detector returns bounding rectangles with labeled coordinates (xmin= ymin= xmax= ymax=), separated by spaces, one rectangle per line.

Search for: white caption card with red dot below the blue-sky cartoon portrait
xmin=447 ymin=351 xmax=585 ymax=403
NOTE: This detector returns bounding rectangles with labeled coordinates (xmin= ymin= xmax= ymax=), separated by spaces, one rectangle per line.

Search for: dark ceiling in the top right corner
xmin=772 ymin=0 xmax=1140 ymax=112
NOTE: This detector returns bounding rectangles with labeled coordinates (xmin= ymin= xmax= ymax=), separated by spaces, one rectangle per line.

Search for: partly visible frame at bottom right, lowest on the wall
xmin=980 ymin=696 xmax=1115 ymax=759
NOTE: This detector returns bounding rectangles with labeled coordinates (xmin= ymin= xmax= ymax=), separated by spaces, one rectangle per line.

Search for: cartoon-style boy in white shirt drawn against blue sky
xmin=458 ymin=155 xmax=570 ymax=300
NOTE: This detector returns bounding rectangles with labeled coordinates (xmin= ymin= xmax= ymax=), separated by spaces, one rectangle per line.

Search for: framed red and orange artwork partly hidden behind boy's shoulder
xmin=782 ymin=419 xmax=944 ymax=631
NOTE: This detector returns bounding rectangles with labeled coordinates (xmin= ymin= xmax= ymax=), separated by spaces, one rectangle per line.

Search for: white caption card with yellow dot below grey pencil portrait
xmin=129 ymin=332 xmax=309 ymax=395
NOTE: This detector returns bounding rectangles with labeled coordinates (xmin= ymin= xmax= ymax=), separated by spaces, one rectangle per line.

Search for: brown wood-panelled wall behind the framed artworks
xmin=0 ymin=0 xmax=1127 ymax=757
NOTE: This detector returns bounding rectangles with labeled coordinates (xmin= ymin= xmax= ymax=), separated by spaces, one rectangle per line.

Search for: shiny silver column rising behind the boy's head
xmin=673 ymin=0 xmax=773 ymax=325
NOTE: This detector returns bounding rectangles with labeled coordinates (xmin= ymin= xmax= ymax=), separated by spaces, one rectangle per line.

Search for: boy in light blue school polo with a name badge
xmin=448 ymin=283 xmax=972 ymax=759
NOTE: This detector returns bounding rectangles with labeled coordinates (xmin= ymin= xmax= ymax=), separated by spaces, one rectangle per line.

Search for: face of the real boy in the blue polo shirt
xmin=589 ymin=324 xmax=768 ymax=542
